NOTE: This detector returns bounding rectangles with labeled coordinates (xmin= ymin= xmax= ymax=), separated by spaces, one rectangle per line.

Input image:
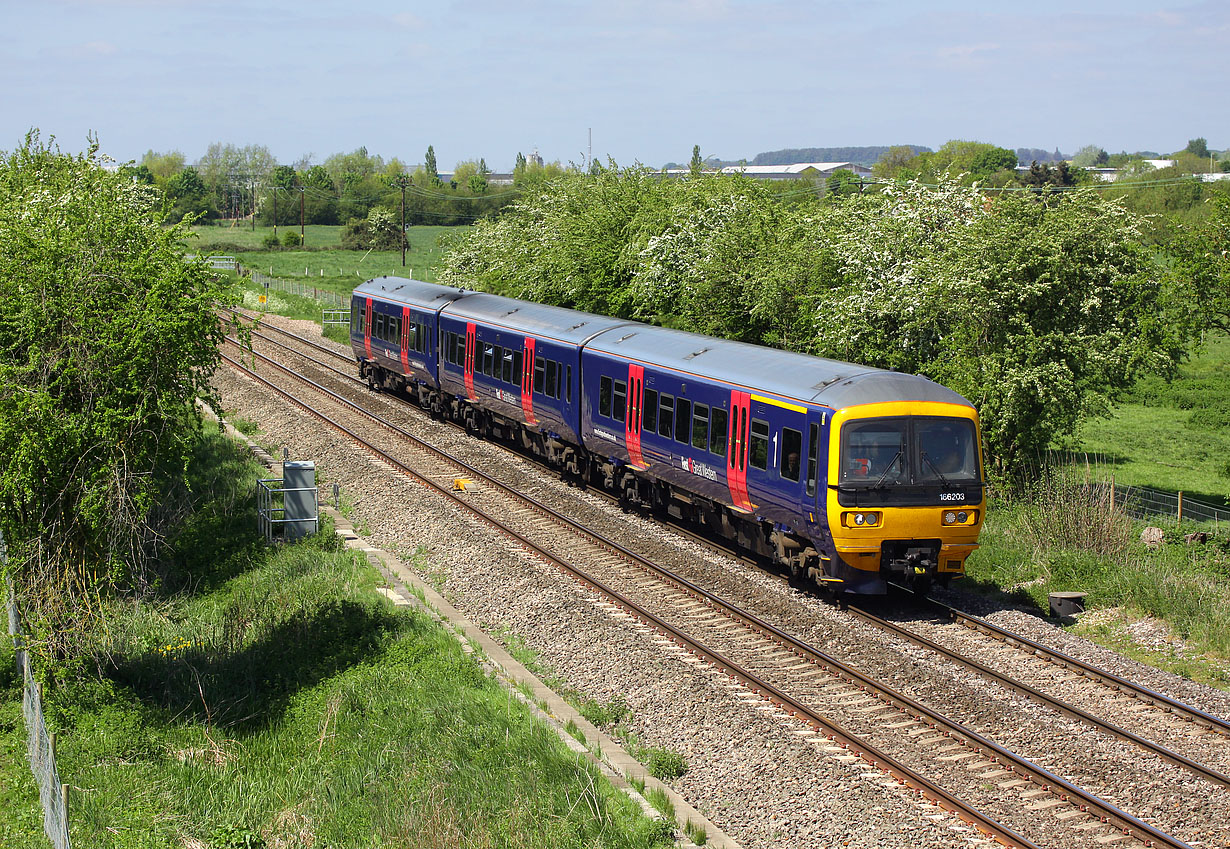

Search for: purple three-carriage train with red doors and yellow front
xmin=349 ymin=277 xmax=986 ymax=596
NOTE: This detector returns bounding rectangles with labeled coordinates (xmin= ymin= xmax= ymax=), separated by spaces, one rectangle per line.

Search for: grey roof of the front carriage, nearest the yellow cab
xmin=585 ymin=325 xmax=970 ymax=410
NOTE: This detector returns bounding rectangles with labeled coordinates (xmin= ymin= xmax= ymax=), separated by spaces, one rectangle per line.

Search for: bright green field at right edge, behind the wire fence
xmin=1076 ymin=336 xmax=1230 ymax=503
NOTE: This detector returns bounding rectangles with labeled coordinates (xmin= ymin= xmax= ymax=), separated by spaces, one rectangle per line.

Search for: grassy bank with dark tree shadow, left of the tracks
xmin=0 ymin=436 xmax=669 ymax=849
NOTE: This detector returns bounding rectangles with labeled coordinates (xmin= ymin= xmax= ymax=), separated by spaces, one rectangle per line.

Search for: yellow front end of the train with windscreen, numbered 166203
xmin=824 ymin=396 xmax=986 ymax=594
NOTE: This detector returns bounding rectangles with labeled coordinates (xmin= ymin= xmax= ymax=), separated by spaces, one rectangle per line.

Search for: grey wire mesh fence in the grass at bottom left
xmin=0 ymin=533 xmax=70 ymax=849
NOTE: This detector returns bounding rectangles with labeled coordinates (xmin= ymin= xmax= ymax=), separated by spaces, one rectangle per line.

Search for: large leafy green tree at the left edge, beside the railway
xmin=0 ymin=132 xmax=234 ymax=655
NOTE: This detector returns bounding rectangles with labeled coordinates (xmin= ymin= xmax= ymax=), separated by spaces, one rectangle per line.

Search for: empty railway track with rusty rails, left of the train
xmin=216 ymin=319 xmax=1225 ymax=847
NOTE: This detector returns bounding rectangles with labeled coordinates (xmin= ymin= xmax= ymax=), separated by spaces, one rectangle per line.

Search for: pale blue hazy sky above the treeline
xmin=0 ymin=0 xmax=1230 ymax=171
